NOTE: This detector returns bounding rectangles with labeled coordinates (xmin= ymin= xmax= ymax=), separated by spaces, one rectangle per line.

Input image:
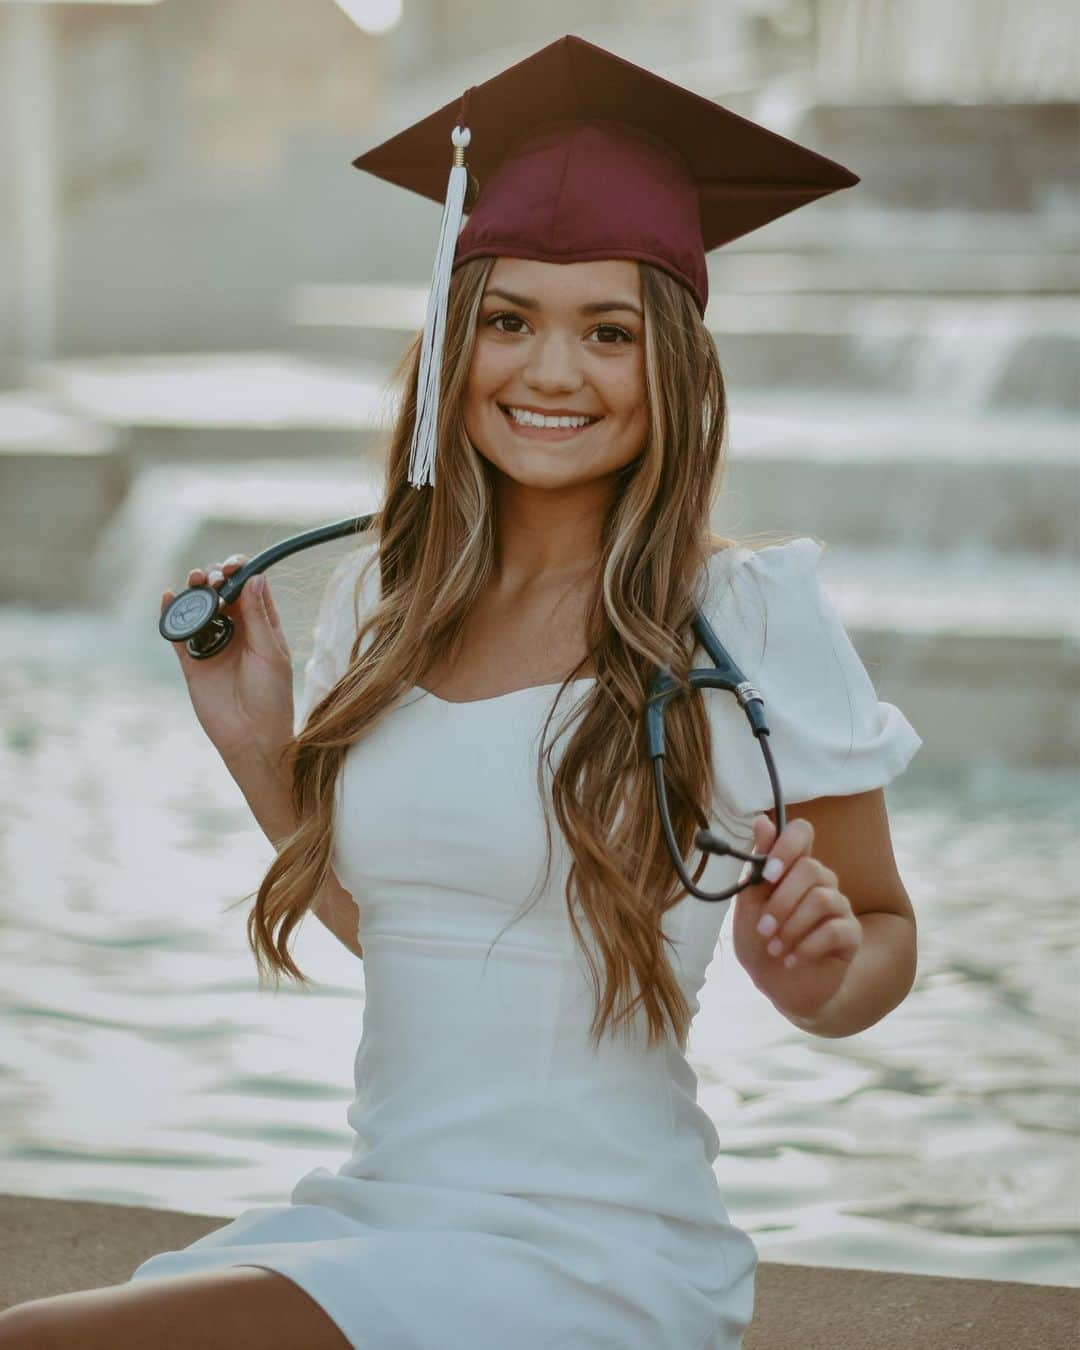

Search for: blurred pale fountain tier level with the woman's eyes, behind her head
xmin=289 ymin=284 xmax=1080 ymax=409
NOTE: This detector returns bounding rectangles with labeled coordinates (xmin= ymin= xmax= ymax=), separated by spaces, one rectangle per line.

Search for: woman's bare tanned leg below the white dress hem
xmin=0 ymin=1266 xmax=350 ymax=1350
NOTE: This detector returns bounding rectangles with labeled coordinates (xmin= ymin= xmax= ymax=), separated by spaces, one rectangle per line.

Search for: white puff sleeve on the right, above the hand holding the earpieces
xmin=706 ymin=537 xmax=922 ymax=836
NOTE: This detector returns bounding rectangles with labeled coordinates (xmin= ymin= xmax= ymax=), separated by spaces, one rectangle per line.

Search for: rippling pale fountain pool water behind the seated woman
xmin=0 ymin=609 xmax=1080 ymax=1285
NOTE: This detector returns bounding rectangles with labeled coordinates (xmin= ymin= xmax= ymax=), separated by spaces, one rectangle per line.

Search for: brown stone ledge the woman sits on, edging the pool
xmin=0 ymin=1195 xmax=1080 ymax=1350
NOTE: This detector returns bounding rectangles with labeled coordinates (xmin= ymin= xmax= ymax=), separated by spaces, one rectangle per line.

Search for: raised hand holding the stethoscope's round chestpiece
xmin=161 ymin=554 xmax=293 ymax=771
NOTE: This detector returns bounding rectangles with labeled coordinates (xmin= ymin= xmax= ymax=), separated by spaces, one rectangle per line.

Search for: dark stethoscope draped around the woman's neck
xmin=158 ymin=512 xmax=786 ymax=900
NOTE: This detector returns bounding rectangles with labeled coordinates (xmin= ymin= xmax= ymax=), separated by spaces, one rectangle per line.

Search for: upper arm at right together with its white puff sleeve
xmin=710 ymin=537 xmax=922 ymax=847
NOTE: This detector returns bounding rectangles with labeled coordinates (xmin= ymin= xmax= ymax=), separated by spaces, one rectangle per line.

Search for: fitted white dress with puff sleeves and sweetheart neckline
xmin=131 ymin=537 xmax=922 ymax=1350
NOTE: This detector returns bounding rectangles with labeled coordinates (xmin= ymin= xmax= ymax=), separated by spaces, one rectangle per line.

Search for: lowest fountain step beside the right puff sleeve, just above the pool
xmin=819 ymin=547 xmax=1080 ymax=767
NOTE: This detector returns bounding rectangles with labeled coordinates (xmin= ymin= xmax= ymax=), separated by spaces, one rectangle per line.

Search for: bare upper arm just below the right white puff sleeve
xmin=765 ymin=787 xmax=915 ymax=923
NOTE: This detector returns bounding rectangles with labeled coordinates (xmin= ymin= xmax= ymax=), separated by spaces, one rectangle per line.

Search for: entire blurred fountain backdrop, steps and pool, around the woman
xmin=0 ymin=0 xmax=1080 ymax=1283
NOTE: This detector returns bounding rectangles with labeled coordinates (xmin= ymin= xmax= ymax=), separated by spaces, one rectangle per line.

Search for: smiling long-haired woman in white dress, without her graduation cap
xmin=0 ymin=36 xmax=921 ymax=1350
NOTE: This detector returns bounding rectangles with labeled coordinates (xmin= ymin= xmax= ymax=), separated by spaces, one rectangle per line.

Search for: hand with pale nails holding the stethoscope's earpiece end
xmin=733 ymin=814 xmax=863 ymax=1018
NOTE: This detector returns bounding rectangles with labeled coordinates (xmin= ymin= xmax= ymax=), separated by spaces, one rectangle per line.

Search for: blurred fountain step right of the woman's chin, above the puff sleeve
xmin=716 ymin=389 xmax=1080 ymax=558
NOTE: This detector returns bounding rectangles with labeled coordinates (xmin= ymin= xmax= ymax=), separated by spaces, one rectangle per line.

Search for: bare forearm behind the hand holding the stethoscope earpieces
xmin=788 ymin=913 xmax=917 ymax=1038
